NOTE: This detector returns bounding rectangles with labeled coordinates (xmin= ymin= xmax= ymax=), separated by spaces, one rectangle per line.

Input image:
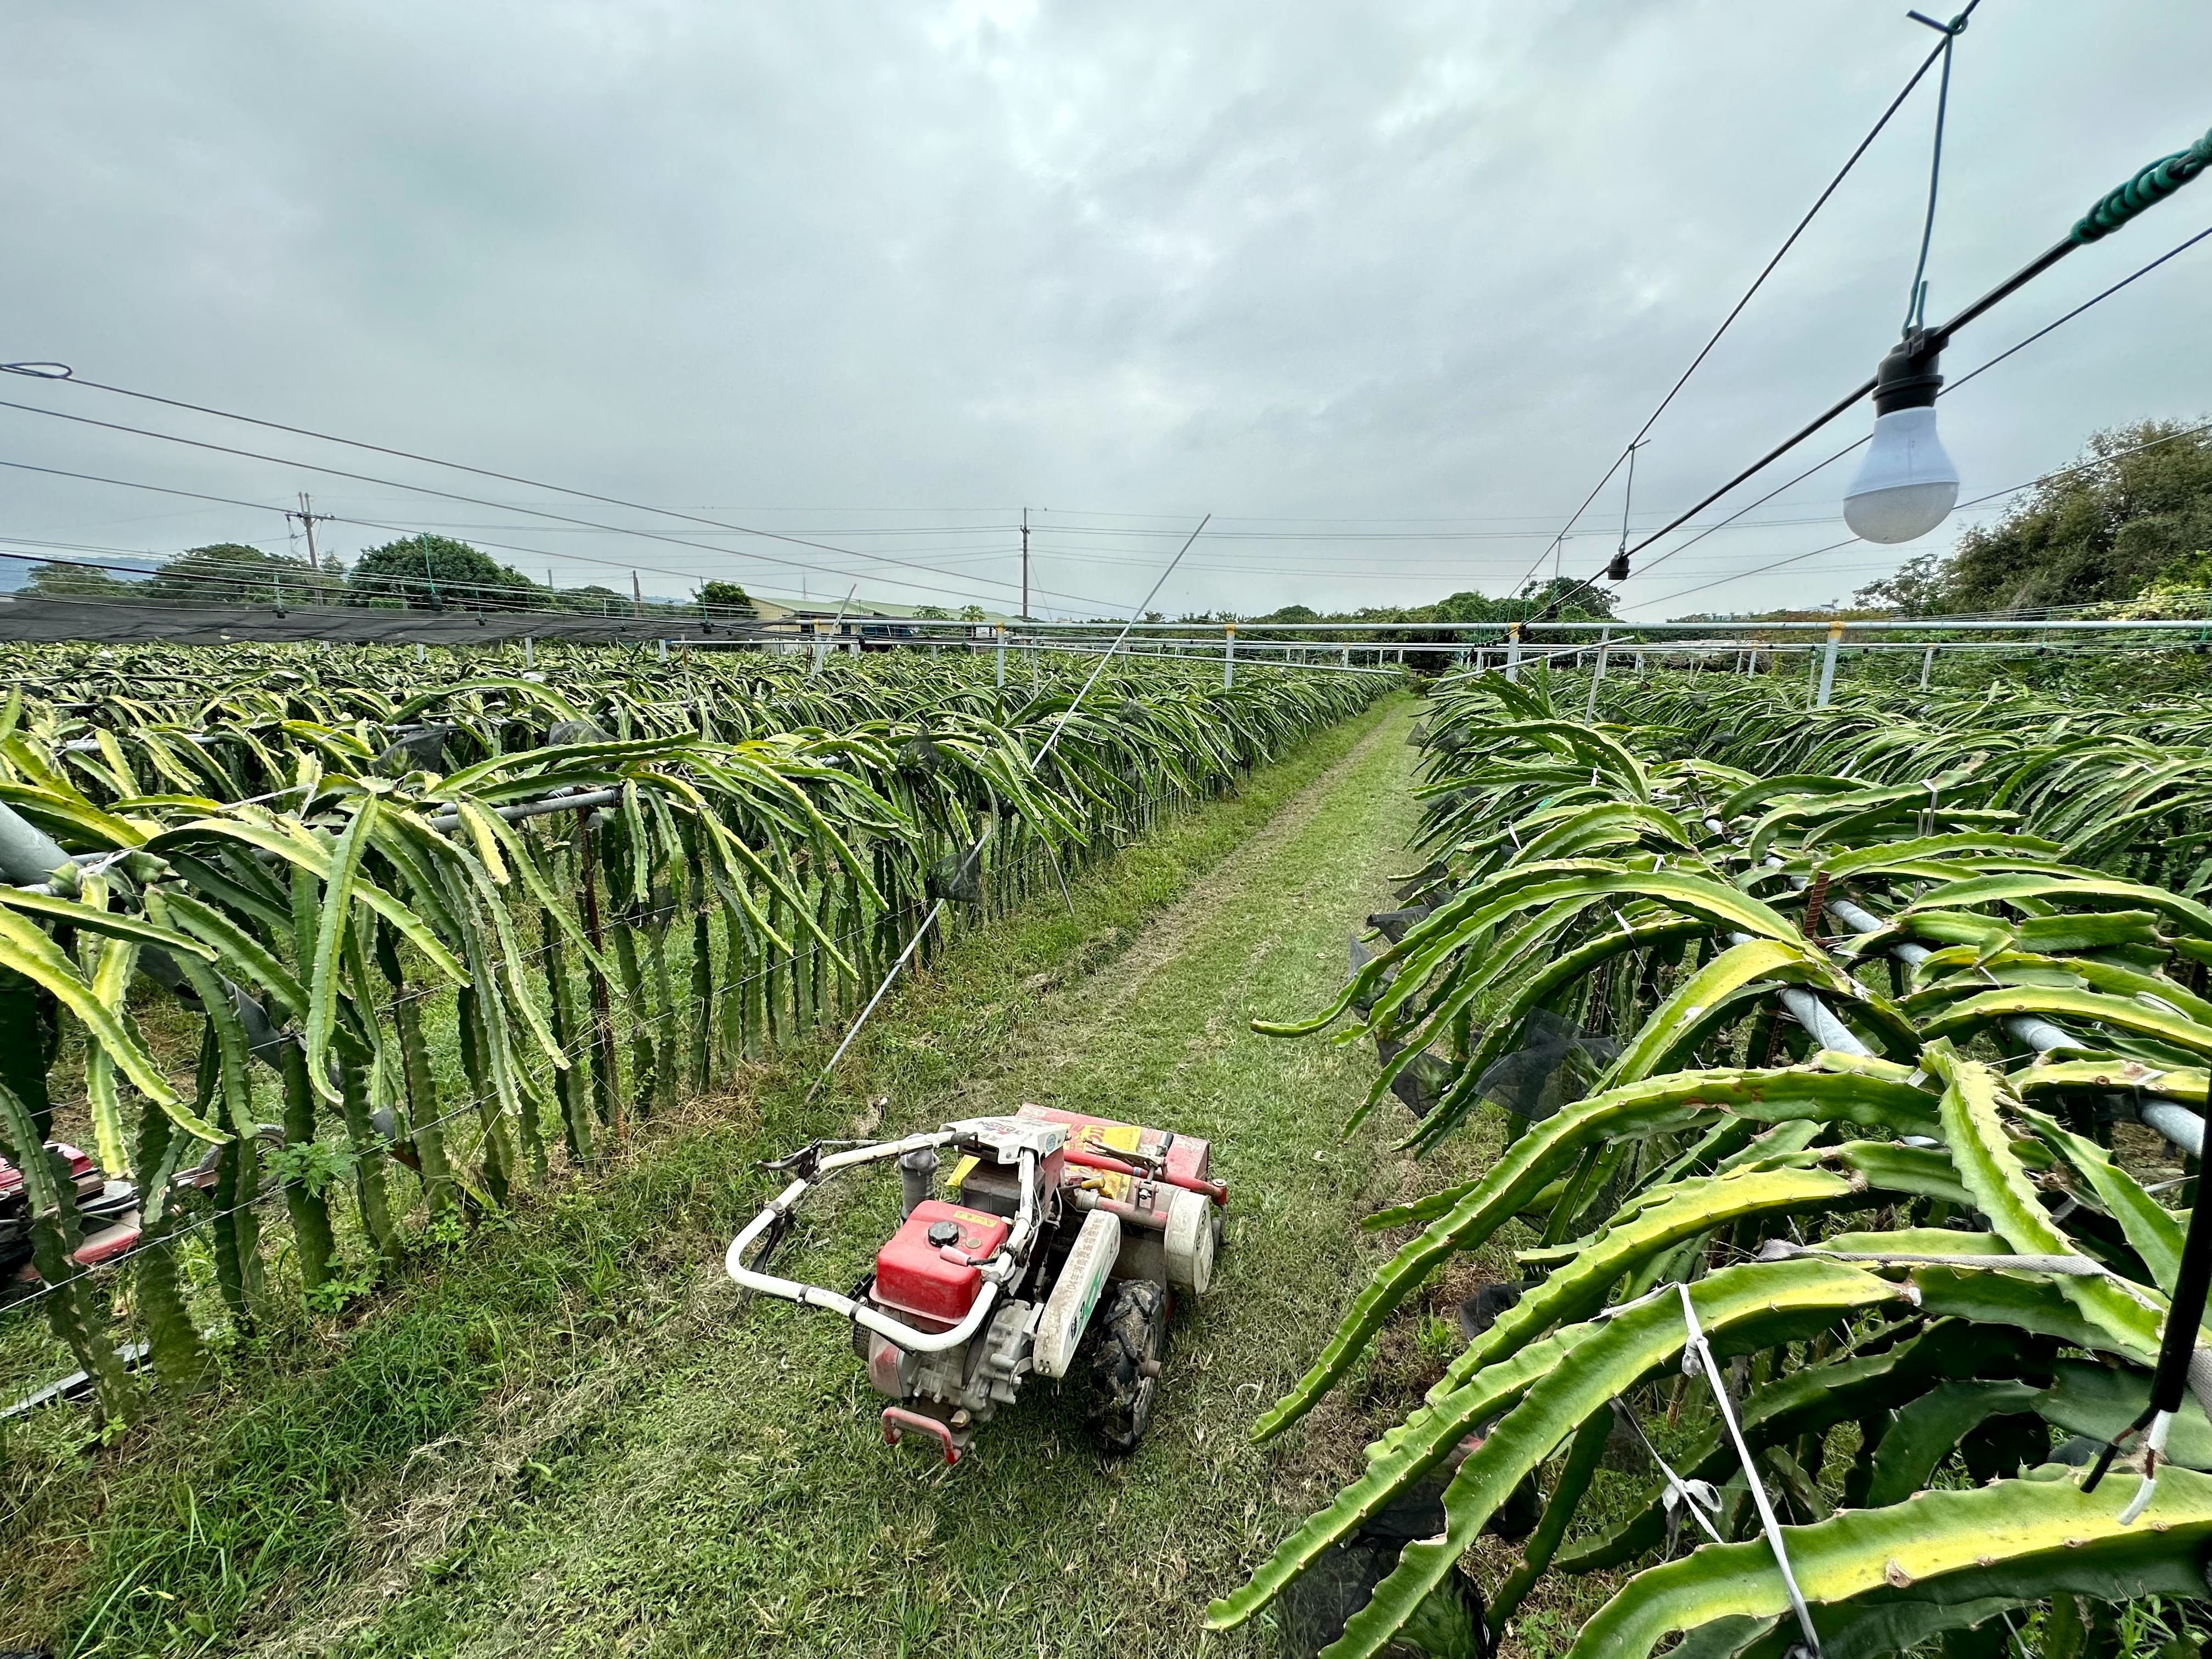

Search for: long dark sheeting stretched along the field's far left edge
xmin=0 ymin=593 xmax=770 ymax=646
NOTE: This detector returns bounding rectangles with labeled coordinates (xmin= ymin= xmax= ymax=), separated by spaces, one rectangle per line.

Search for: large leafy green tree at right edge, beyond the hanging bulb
xmin=1940 ymin=420 xmax=2212 ymax=611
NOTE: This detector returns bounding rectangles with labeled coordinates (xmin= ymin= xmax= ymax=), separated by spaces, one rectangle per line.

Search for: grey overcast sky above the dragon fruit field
xmin=0 ymin=0 xmax=2212 ymax=617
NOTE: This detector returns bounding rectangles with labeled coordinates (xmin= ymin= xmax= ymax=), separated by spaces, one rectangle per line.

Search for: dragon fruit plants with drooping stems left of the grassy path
xmin=0 ymin=646 xmax=1385 ymax=1420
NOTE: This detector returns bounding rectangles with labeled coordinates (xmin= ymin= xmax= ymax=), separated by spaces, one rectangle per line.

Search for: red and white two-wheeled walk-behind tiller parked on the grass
xmin=725 ymin=1104 xmax=1228 ymax=1462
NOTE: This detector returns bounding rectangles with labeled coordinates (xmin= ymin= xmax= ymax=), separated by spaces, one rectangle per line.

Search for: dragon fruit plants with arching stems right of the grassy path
xmin=1210 ymin=675 xmax=2212 ymax=1659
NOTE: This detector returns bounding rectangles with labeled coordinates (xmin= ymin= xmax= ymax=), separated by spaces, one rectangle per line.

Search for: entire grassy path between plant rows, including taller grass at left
xmin=0 ymin=703 xmax=1413 ymax=1659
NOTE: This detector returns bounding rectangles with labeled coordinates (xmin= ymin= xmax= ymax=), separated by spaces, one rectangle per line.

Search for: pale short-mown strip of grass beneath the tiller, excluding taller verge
xmin=251 ymin=708 xmax=1413 ymax=1659
